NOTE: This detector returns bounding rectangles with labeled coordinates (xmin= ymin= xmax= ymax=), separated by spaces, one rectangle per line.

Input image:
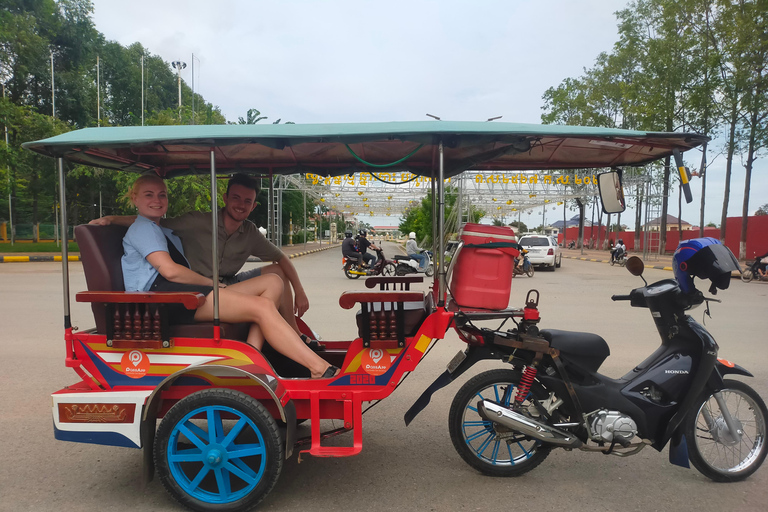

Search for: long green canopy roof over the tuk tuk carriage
xmin=23 ymin=121 xmax=709 ymax=177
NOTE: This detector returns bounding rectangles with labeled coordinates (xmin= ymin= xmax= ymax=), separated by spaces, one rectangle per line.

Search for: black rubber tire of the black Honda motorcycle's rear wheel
xmin=448 ymin=369 xmax=552 ymax=477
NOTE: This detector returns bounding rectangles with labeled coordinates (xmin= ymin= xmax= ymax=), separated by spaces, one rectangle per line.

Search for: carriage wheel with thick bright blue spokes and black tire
xmin=154 ymin=389 xmax=283 ymax=511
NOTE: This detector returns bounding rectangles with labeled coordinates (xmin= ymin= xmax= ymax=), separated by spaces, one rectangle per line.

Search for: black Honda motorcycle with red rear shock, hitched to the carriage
xmin=426 ymin=256 xmax=768 ymax=481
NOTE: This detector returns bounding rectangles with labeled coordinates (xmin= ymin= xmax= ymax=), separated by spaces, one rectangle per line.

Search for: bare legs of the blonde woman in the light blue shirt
xmin=195 ymin=288 xmax=330 ymax=378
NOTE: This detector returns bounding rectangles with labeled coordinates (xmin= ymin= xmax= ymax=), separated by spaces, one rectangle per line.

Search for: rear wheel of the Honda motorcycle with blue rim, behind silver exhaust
xmin=448 ymin=370 xmax=551 ymax=476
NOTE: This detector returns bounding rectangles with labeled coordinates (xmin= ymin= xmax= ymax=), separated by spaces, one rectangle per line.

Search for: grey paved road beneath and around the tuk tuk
xmin=0 ymin=245 xmax=768 ymax=512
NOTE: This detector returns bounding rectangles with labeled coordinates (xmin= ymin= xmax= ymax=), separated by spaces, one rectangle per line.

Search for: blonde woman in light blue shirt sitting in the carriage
xmin=121 ymin=174 xmax=340 ymax=378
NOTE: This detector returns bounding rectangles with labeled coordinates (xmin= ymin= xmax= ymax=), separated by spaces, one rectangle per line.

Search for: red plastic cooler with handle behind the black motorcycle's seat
xmin=450 ymin=224 xmax=520 ymax=309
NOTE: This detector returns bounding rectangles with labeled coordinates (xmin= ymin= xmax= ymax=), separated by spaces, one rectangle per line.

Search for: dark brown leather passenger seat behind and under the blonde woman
xmin=75 ymin=224 xmax=249 ymax=341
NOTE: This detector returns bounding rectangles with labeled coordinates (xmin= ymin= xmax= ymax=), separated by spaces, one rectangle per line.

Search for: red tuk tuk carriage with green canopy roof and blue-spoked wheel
xmin=25 ymin=122 xmax=707 ymax=510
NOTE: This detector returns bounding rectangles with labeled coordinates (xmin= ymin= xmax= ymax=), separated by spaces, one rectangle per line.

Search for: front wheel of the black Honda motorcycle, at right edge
xmin=685 ymin=379 xmax=768 ymax=482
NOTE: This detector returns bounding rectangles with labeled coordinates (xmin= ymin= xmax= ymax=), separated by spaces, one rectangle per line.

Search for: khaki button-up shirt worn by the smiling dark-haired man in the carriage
xmin=160 ymin=210 xmax=285 ymax=277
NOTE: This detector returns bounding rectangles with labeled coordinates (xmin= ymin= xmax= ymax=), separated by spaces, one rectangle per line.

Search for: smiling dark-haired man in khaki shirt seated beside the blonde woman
xmin=91 ymin=174 xmax=321 ymax=350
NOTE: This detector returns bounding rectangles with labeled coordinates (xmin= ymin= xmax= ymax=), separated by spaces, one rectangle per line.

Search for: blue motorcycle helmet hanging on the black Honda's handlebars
xmin=672 ymin=237 xmax=741 ymax=295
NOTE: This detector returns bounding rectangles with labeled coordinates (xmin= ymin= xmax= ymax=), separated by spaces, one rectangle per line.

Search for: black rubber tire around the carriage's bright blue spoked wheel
xmin=154 ymin=388 xmax=284 ymax=512
